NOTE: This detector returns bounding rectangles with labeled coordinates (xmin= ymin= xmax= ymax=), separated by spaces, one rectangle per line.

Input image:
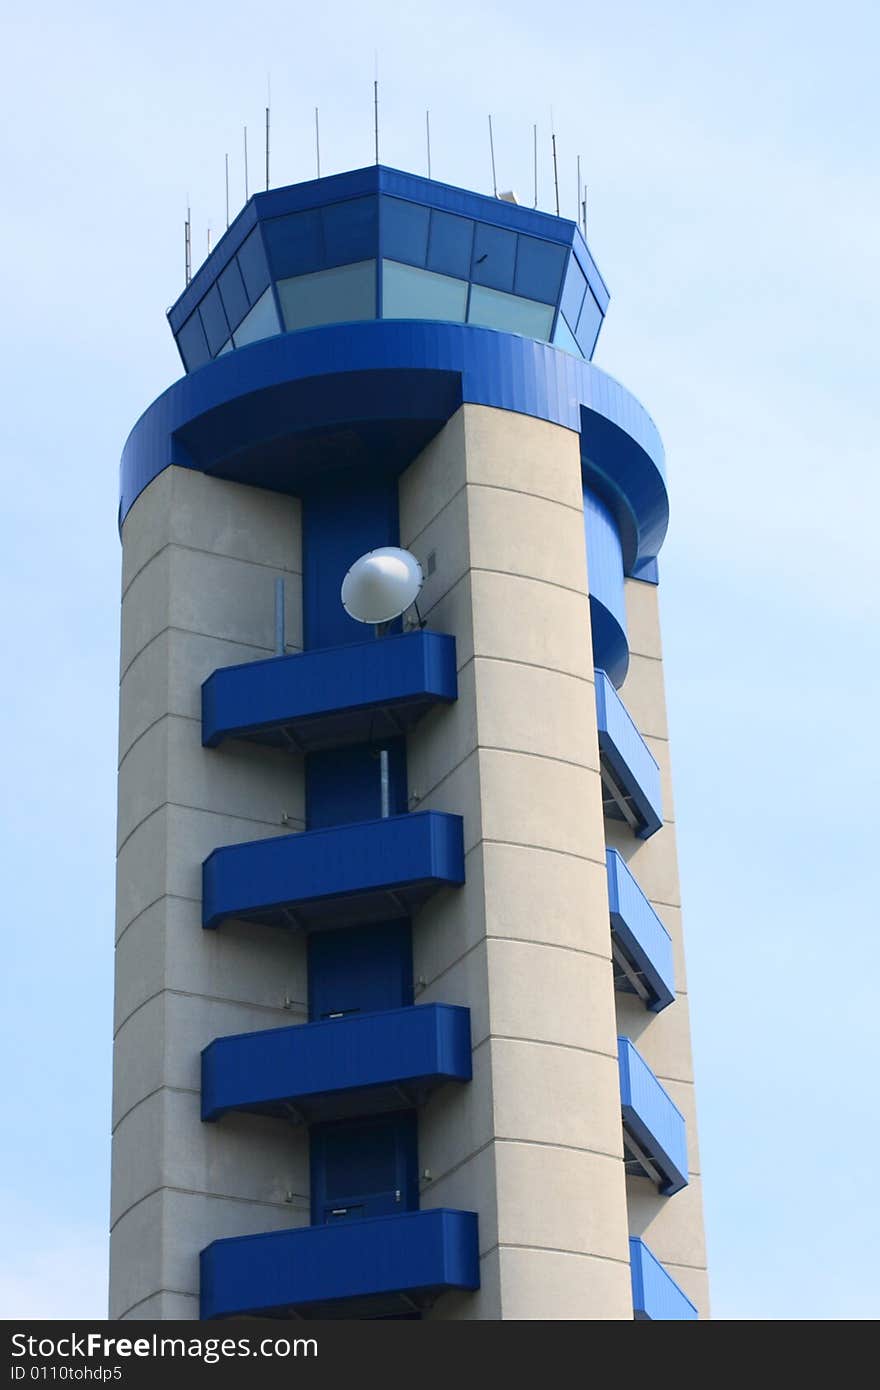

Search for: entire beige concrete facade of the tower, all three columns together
xmin=110 ymin=406 xmax=708 ymax=1319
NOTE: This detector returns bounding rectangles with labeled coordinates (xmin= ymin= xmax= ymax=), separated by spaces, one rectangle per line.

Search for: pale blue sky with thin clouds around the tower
xmin=0 ymin=0 xmax=880 ymax=1321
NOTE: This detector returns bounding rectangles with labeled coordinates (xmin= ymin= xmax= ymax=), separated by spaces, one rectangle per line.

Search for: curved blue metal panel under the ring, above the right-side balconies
xmin=584 ymin=488 xmax=630 ymax=685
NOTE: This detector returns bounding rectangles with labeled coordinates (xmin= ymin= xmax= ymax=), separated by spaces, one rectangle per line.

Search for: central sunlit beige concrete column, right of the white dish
xmin=400 ymin=406 xmax=633 ymax=1319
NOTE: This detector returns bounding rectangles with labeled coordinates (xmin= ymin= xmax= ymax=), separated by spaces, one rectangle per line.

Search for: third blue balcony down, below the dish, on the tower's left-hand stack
xmin=202 ymin=1004 xmax=471 ymax=1123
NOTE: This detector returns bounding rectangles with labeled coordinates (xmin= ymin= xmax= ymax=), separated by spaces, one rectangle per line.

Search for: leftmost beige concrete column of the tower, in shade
xmin=110 ymin=467 xmax=309 ymax=1318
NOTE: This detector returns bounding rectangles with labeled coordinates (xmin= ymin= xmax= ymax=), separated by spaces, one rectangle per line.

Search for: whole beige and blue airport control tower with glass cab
xmin=110 ymin=165 xmax=708 ymax=1319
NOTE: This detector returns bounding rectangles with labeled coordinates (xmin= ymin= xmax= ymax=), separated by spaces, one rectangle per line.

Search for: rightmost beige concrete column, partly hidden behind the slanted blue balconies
xmin=608 ymin=580 xmax=709 ymax=1318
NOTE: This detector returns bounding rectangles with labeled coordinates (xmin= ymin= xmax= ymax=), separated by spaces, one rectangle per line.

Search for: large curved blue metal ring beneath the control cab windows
xmin=120 ymin=320 xmax=669 ymax=573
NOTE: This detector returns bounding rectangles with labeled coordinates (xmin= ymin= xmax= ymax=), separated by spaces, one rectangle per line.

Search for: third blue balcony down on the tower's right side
xmin=617 ymin=1038 xmax=688 ymax=1197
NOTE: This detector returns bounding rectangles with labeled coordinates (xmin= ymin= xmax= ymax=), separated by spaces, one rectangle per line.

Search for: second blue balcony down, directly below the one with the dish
xmin=202 ymin=810 xmax=464 ymax=929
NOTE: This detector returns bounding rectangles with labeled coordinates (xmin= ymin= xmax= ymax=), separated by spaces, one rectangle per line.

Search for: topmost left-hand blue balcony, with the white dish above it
xmin=202 ymin=631 xmax=457 ymax=752
